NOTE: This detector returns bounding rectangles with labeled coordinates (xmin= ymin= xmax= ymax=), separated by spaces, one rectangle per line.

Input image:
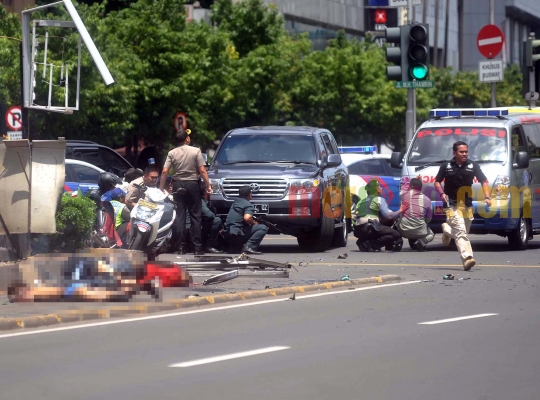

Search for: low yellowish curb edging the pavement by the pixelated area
xmin=0 ymin=275 xmax=402 ymax=331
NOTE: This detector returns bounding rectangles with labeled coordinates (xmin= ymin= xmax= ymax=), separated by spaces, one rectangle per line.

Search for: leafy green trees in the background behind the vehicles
xmin=0 ymin=0 xmax=524 ymax=156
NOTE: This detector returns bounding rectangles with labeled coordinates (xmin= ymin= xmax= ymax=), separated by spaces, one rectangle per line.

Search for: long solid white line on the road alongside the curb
xmin=0 ymin=281 xmax=422 ymax=339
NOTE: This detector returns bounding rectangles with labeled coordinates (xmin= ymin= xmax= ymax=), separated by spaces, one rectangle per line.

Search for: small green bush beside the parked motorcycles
xmin=55 ymin=193 xmax=96 ymax=250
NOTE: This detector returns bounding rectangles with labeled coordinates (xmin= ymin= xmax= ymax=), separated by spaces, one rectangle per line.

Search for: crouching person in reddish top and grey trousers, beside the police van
xmin=397 ymin=178 xmax=435 ymax=251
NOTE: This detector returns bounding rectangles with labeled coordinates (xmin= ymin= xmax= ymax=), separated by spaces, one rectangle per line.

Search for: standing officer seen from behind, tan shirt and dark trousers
xmin=159 ymin=128 xmax=212 ymax=255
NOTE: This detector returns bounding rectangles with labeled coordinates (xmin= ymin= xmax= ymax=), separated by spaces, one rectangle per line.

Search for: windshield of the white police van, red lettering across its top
xmin=408 ymin=126 xmax=507 ymax=165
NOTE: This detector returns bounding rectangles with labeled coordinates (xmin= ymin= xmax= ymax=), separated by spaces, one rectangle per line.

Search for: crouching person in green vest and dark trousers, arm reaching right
xmin=354 ymin=179 xmax=408 ymax=252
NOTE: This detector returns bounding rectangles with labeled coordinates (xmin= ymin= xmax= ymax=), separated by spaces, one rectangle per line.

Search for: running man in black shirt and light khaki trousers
xmin=435 ymin=141 xmax=491 ymax=271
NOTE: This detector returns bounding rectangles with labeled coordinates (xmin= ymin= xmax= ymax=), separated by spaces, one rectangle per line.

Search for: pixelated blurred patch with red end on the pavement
xmin=8 ymin=249 xmax=191 ymax=302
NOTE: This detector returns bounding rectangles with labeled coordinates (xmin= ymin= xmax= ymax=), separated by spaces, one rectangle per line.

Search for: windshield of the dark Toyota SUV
xmin=214 ymin=134 xmax=317 ymax=165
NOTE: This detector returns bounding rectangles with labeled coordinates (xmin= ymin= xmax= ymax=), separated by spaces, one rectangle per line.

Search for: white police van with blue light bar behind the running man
xmin=392 ymin=107 xmax=540 ymax=250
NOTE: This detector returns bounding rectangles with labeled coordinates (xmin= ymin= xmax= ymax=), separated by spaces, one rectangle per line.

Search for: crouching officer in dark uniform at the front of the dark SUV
xmin=224 ymin=185 xmax=268 ymax=254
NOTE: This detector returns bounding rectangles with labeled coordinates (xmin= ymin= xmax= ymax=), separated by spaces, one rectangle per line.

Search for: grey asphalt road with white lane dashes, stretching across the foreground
xmin=0 ymin=236 xmax=540 ymax=400
